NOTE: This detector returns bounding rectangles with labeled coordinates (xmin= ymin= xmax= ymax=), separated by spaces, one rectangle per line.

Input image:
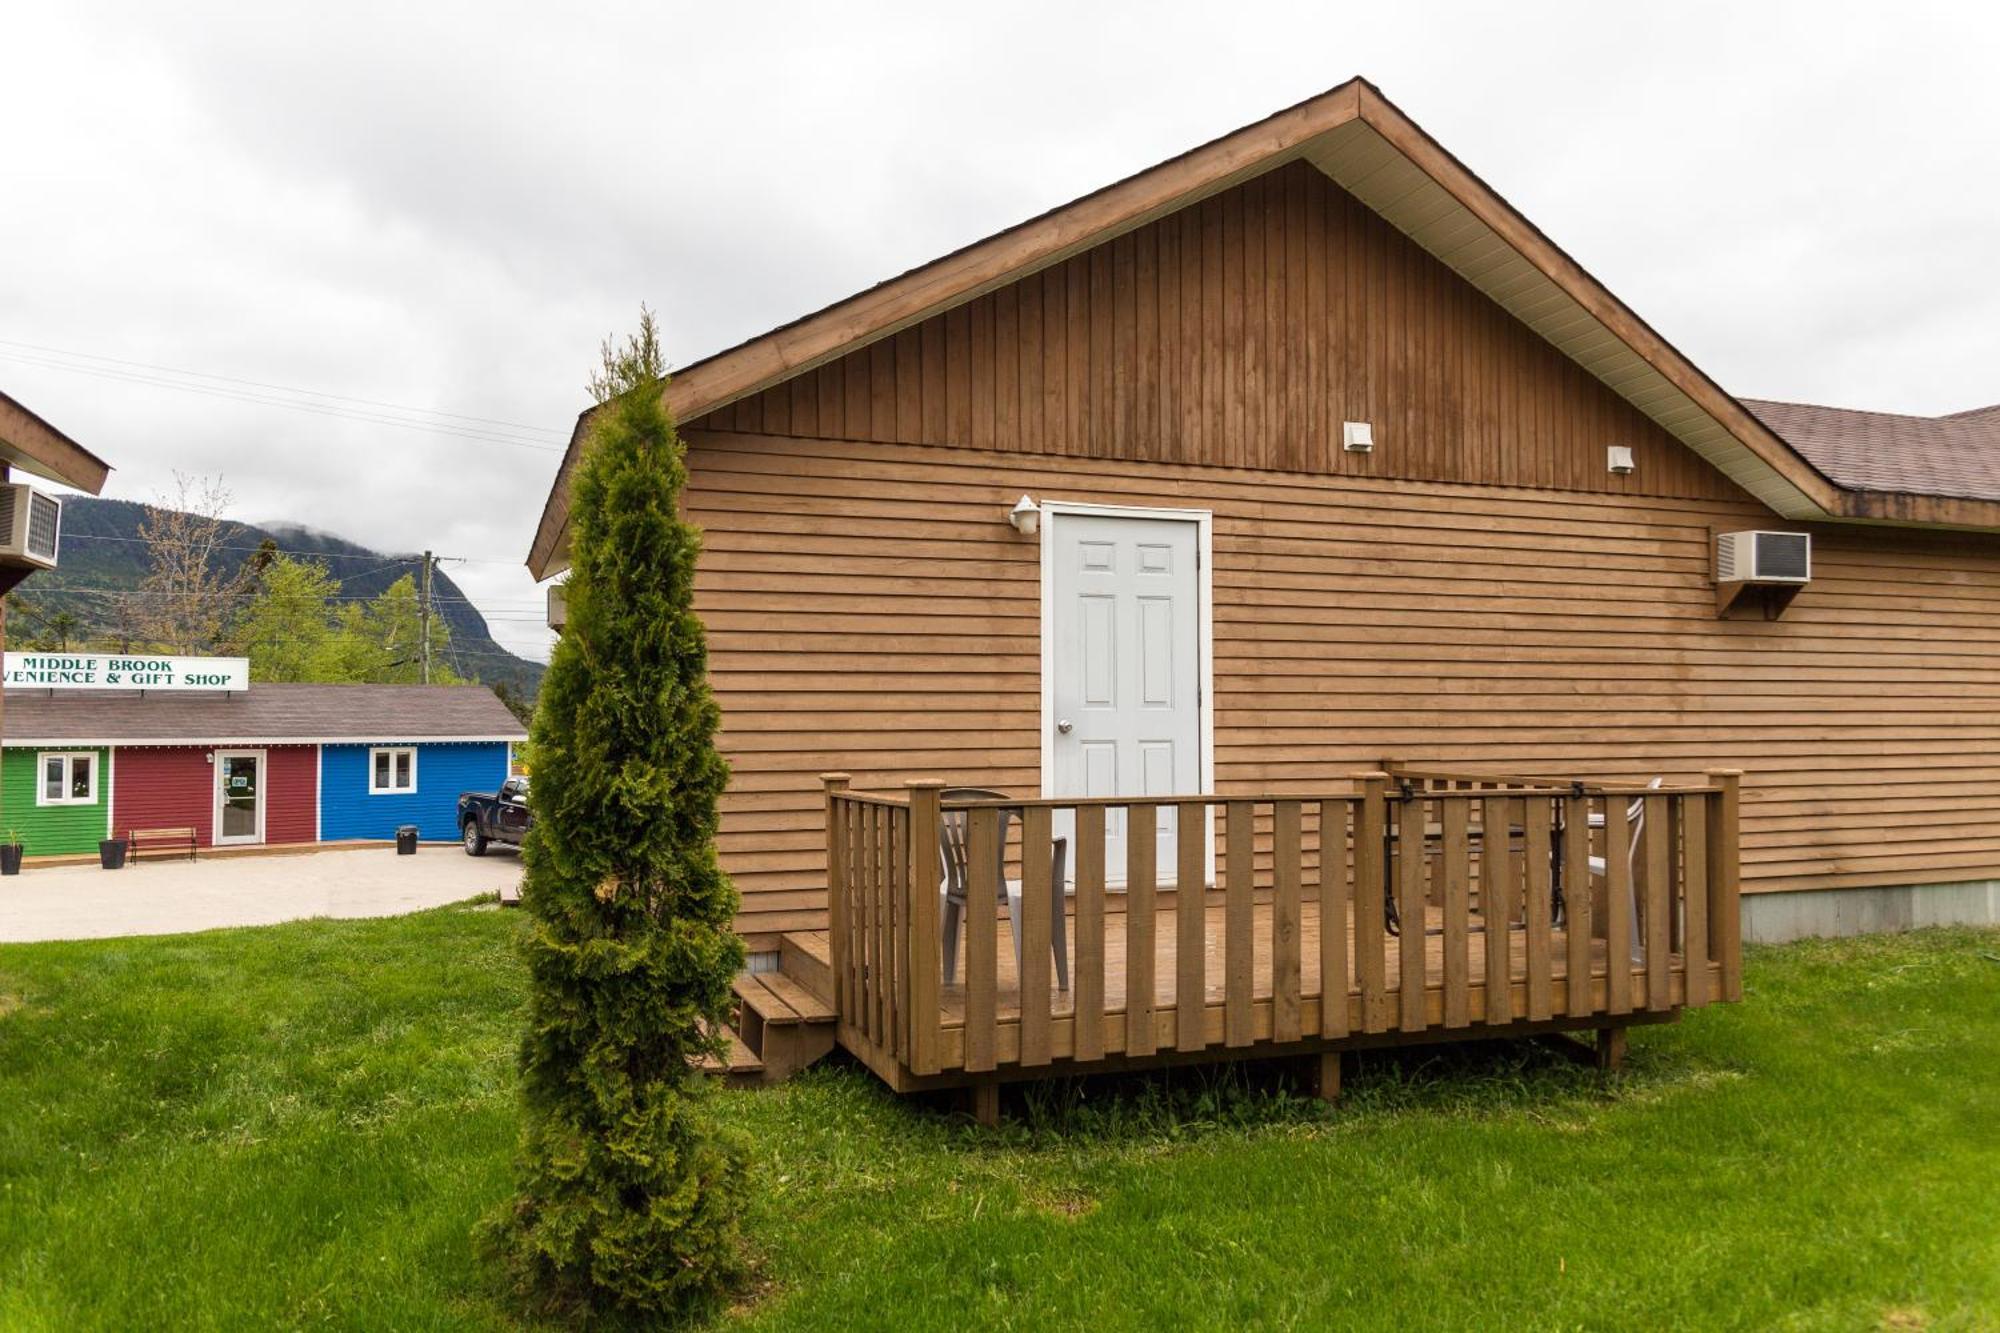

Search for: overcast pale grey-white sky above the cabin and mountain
xmin=0 ymin=0 xmax=2000 ymax=656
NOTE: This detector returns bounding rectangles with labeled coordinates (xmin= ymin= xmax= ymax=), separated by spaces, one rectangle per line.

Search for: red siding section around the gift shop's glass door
xmin=112 ymin=745 xmax=320 ymax=847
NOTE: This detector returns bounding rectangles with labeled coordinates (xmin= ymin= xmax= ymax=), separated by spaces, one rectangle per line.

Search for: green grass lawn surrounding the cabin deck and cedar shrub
xmin=0 ymin=907 xmax=2000 ymax=1329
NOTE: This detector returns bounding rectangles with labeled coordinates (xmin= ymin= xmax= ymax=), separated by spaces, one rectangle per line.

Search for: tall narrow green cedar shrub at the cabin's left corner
xmin=486 ymin=312 xmax=746 ymax=1317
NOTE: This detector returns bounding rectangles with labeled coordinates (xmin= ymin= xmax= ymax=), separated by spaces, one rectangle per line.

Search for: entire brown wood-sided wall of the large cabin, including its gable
xmin=684 ymin=164 xmax=2000 ymax=949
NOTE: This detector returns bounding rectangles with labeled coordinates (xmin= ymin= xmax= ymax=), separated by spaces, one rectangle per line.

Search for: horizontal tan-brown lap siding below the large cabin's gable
xmin=688 ymin=432 xmax=2000 ymax=939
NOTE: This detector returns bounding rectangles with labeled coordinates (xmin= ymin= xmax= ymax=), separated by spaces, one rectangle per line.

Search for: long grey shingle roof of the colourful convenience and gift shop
xmin=0 ymin=685 xmax=528 ymax=745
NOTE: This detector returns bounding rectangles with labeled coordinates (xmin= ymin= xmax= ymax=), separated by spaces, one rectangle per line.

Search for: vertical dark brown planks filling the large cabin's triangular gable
xmin=690 ymin=162 xmax=1740 ymax=498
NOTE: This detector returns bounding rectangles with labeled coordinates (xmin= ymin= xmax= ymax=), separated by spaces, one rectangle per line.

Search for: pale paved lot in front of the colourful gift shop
xmin=0 ymin=845 xmax=520 ymax=941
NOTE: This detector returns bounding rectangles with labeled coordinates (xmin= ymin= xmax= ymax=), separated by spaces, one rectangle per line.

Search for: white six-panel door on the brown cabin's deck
xmin=1044 ymin=510 xmax=1204 ymax=883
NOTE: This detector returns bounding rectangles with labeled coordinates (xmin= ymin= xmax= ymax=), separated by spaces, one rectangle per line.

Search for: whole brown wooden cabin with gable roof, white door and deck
xmin=530 ymin=80 xmax=2000 ymax=1087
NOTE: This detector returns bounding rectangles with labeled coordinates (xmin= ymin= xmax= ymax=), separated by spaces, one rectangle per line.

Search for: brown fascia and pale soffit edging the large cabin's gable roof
xmin=528 ymin=78 xmax=2000 ymax=578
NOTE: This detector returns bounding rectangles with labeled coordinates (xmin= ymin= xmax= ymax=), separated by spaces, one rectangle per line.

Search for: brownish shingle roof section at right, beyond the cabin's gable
xmin=1740 ymin=398 xmax=2000 ymax=500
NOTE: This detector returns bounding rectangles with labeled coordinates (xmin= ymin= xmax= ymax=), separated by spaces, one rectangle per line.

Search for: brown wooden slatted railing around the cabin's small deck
xmin=824 ymin=769 xmax=1742 ymax=1075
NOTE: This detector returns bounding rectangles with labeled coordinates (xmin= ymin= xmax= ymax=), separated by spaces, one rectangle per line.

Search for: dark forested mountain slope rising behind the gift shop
xmin=20 ymin=496 xmax=542 ymax=699
